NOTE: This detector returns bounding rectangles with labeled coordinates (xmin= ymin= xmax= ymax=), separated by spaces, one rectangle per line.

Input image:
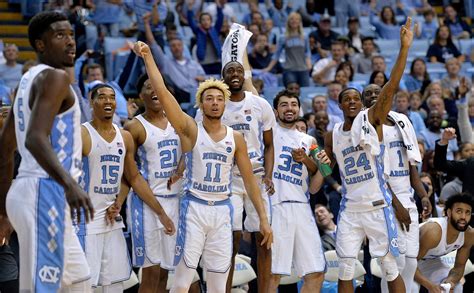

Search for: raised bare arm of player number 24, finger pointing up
xmin=369 ymin=17 xmax=416 ymax=132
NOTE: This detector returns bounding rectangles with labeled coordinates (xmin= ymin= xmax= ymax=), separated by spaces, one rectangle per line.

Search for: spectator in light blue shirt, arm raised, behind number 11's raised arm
xmin=144 ymin=15 xmax=206 ymax=103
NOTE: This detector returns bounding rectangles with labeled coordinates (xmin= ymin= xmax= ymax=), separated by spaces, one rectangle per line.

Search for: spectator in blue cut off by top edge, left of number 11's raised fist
xmin=94 ymin=0 xmax=122 ymax=38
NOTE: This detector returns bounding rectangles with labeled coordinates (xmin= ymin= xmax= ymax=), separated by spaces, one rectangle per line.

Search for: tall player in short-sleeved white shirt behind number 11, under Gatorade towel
xmin=196 ymin=61 xmax=275 ymax=292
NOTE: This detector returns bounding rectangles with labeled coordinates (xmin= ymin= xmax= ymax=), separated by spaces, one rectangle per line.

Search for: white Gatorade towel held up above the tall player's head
xmin=221 ymin=23 xmax=253 ymax=69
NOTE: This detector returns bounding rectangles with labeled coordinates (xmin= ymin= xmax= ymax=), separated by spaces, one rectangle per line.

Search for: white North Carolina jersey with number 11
xmin=184 ymin=122 xmax=235 ymax=201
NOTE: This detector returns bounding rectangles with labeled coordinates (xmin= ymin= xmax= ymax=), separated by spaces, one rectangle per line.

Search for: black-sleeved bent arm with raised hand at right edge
xmin=434 ymin=128 xmax=474 ymax=194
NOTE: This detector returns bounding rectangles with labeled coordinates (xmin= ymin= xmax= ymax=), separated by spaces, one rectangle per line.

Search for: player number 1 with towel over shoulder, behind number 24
xmin=362 ymin=84 xmax=431 ymax=292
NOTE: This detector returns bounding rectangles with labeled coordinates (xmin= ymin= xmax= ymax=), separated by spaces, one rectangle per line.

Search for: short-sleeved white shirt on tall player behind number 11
xmin=196 ymin=92 xmax=276 ymax=174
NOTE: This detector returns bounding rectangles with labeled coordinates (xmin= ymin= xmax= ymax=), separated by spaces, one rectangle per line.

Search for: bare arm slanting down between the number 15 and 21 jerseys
xmin=121 ymin=130 xmax=175 ymax=235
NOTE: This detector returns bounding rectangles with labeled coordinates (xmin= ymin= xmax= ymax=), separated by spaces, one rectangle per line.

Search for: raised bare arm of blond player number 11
xmin=134 ymin=42 xmax=197 ymax=137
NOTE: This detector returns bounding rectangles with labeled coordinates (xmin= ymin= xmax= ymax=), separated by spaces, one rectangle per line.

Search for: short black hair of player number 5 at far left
xmin=28 ymin=11 xmax=68 ymax=51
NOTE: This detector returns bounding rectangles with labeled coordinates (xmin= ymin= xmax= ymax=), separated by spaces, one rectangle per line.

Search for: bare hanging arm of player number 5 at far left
xmin=26 ymin=69 xmax=94 ymax=221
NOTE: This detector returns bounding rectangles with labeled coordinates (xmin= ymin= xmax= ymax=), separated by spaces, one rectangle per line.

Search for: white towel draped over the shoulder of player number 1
xmin=388 ymin=111 xmax=421 ymax=165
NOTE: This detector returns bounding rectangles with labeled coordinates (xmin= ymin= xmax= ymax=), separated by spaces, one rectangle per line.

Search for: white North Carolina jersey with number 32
xmin=272 ymin=125 xmax=314 ymax=205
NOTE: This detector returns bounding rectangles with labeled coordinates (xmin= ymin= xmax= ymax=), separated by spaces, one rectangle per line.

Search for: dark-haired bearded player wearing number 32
xmin=269 ymin=90 xmax=330 ymax=292
